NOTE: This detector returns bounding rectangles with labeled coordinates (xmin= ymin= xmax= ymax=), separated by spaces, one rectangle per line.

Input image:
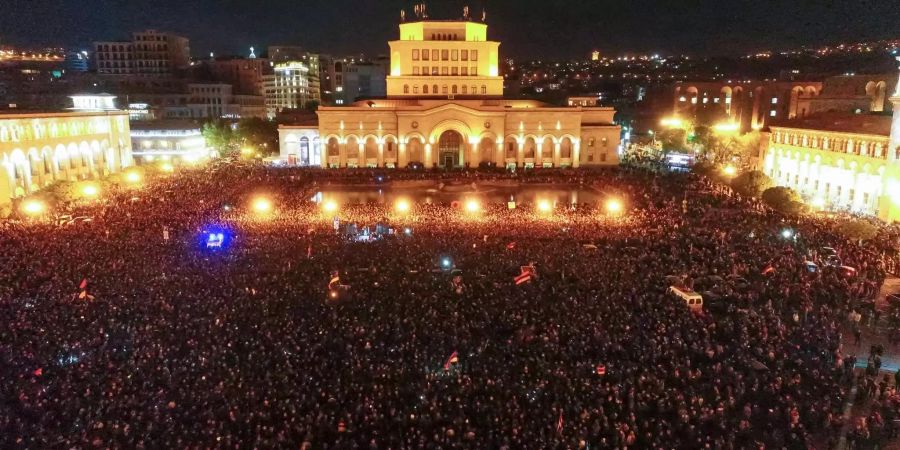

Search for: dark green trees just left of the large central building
xmin=202 ymin=118 xmax=278 ymax=156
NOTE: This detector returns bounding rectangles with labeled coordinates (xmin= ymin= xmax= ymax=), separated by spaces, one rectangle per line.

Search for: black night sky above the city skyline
xmin=0 ymin=0 xmax=900 ymax=59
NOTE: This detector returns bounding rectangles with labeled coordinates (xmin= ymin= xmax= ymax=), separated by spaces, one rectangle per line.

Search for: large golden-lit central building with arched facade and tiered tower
xmin=279 ymin=8 xmax=620 ymax=168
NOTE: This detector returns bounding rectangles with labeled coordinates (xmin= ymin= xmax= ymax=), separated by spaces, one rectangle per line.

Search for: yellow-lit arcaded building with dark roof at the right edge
xmin=762 ymin=74 xmax=900 ymax=221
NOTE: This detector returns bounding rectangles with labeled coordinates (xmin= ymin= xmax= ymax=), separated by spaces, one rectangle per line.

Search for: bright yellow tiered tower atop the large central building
xmin=387 ymin=5 xmax=503 ymax=98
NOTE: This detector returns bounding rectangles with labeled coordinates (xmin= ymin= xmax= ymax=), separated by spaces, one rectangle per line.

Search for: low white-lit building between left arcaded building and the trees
xmin=131 ymin=120 xmax=210 ymax=163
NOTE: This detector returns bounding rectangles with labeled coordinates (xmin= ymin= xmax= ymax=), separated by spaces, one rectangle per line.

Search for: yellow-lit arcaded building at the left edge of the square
xmin=0 ymin=111 xmax=132 ymax=207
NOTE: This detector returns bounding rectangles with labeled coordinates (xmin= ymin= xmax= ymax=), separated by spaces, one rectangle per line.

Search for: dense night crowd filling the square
xmin=0 ymin=166 xmax=898 ymax=449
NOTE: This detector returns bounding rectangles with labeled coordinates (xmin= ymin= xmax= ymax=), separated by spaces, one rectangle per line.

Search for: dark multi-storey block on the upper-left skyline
xmin=94 ymin=30 xmax=191 ymax=77
